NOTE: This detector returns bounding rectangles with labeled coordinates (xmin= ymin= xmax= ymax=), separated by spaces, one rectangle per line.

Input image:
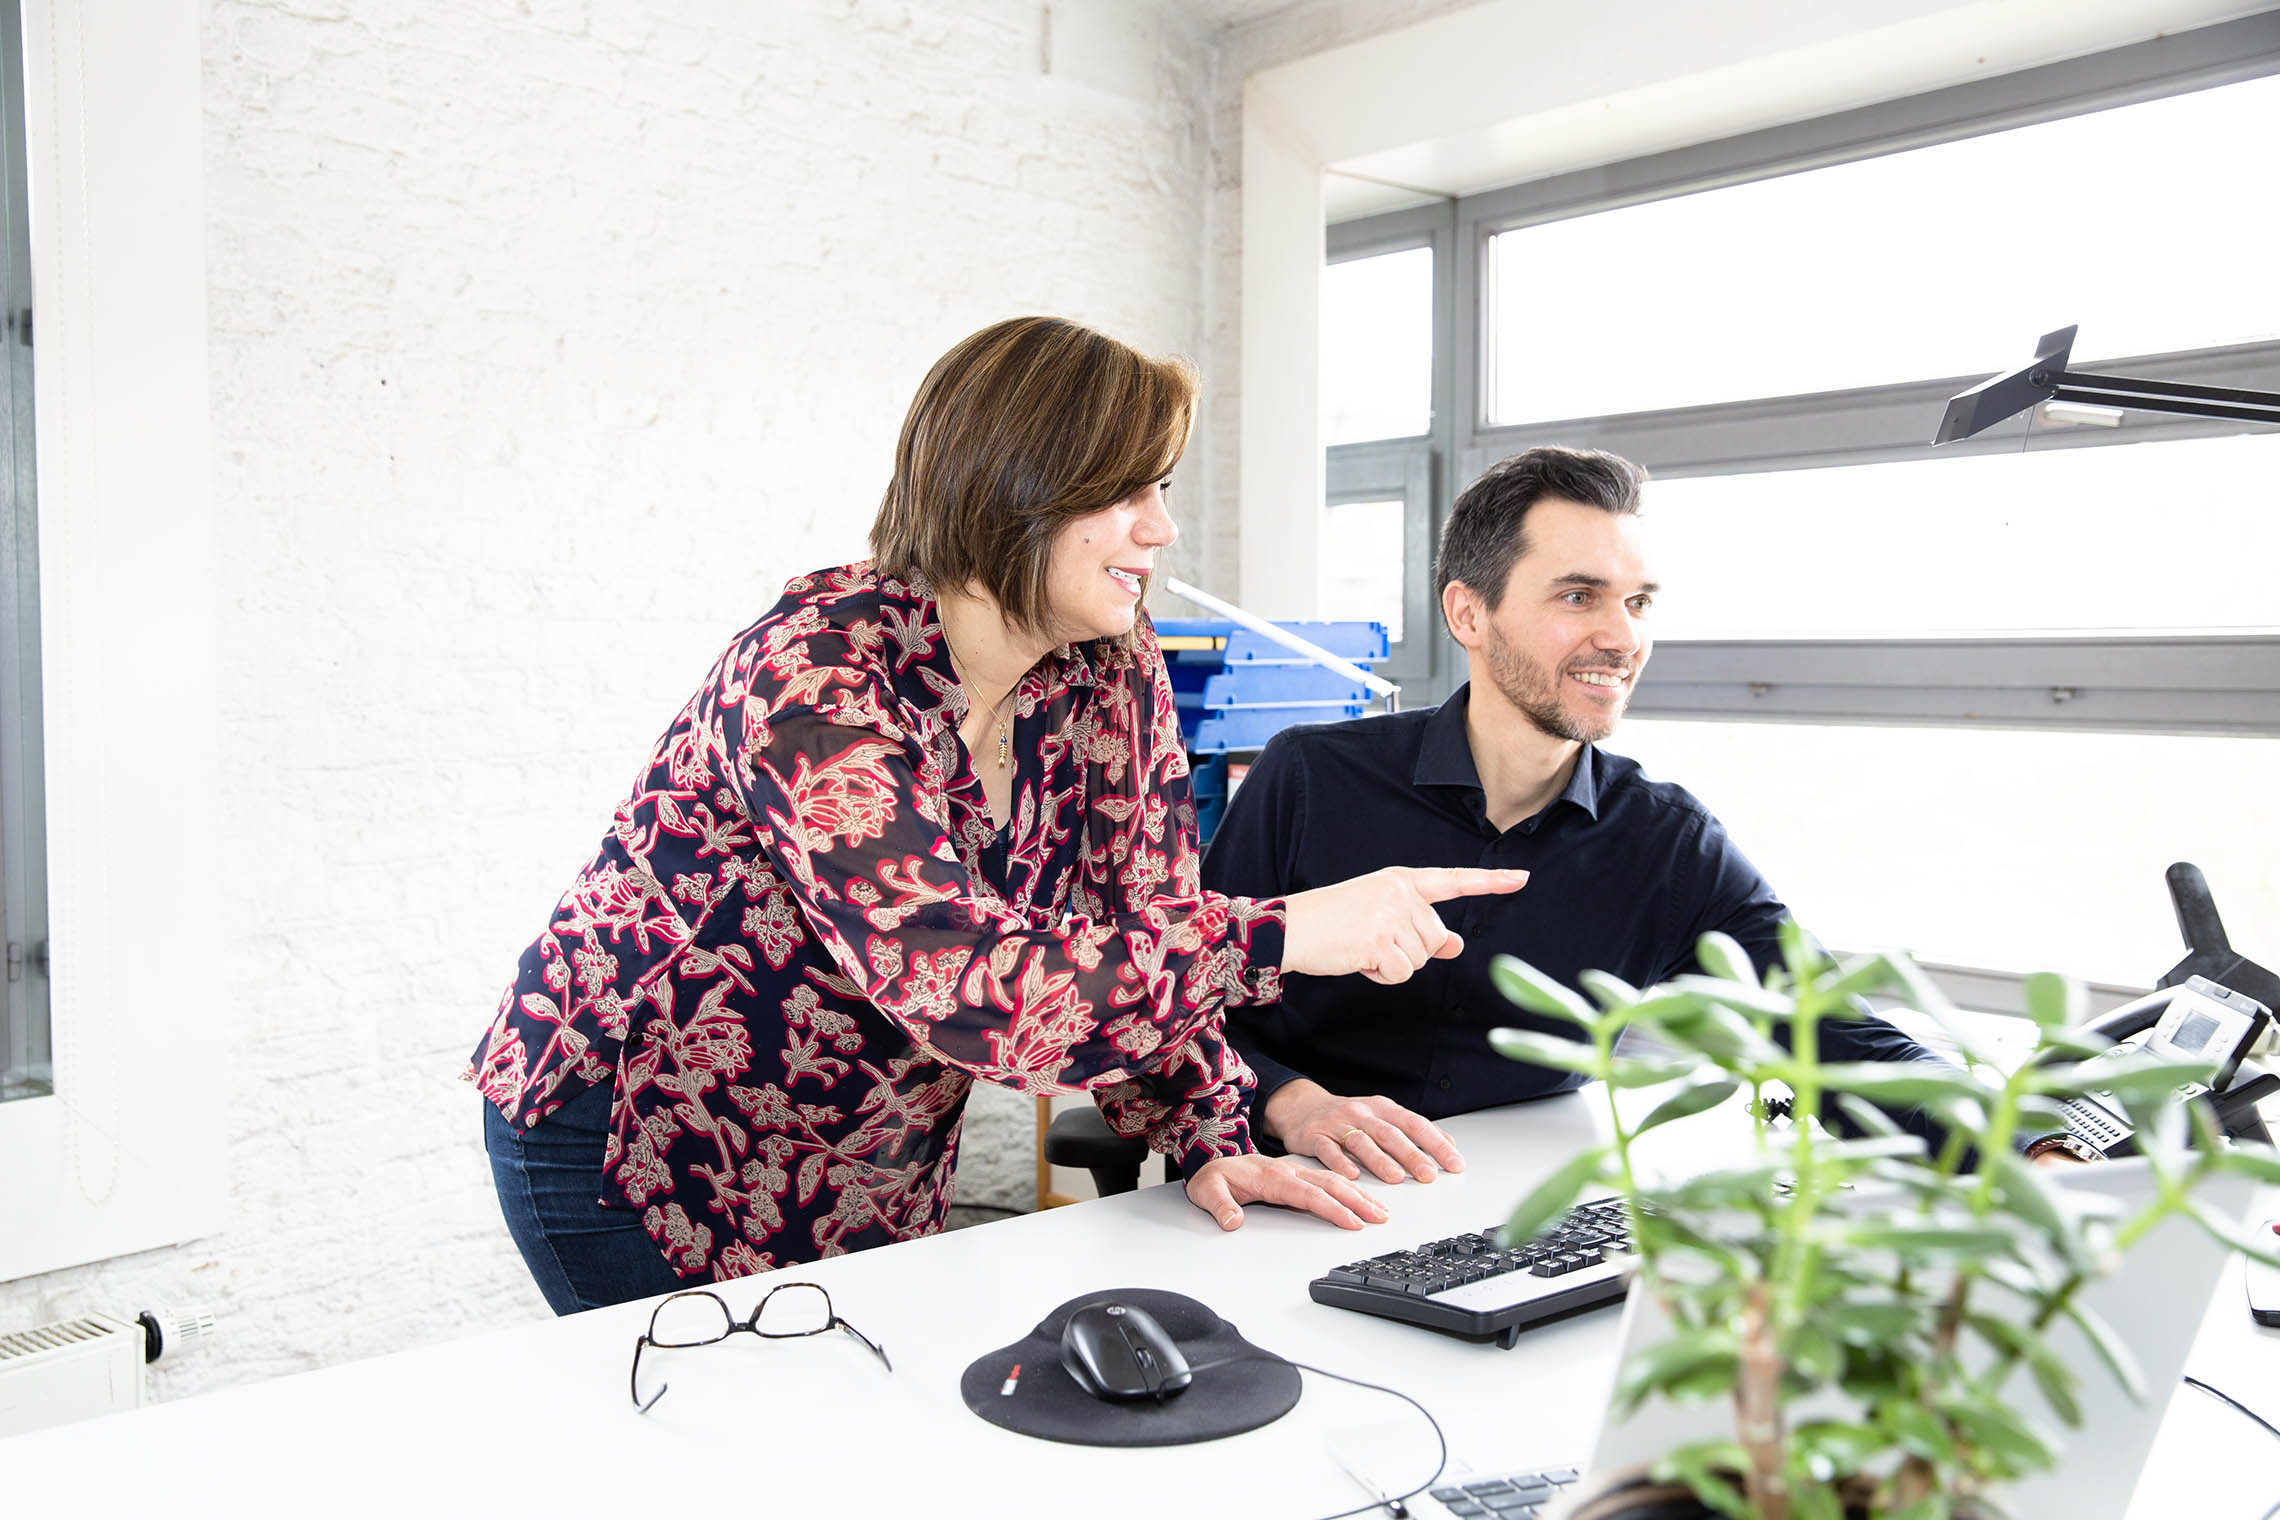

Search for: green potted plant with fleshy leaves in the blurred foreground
xmin=1491 ymin=923 xmax=2280 ymax=1520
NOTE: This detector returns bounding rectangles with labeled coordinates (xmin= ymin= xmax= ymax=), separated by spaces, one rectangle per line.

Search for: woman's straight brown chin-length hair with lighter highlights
xmin=871 ymin=317 xmax=1195 ymax=629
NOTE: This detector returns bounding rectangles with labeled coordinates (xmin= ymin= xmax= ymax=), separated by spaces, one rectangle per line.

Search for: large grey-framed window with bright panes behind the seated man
xmin=1325 ymin=11 xmax=2280 ymax=984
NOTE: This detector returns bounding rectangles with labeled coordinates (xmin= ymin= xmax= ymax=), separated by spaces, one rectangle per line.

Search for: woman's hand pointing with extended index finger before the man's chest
xmin=1281 ymin=866 xmax=1528 ymax=984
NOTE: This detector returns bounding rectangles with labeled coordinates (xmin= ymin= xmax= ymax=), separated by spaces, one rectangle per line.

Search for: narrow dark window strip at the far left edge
xmin=0 ymin=0 xmax=55 ymax=1103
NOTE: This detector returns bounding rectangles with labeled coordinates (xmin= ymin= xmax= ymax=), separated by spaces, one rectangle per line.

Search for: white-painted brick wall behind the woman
xmin=0 ymin=0 xmax=1211 ymax=1397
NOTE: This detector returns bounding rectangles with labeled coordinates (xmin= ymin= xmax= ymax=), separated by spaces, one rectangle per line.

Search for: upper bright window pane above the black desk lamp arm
xmin=1487 ymin=77 xmax=2280 ymax=426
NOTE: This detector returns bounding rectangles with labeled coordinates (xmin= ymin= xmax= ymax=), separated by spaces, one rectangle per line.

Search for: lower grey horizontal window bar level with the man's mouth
xmin=1630 ymin=634 xmax=2280 ymax=736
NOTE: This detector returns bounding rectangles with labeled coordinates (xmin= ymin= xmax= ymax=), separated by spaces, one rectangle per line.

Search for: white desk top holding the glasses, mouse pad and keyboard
xmin=13 ymin=1094 xmax=2280 ymax=1520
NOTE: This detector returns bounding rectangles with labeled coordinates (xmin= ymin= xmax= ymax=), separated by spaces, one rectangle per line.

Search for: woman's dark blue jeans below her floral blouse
xmin=483 ymin=1082 xmax=689 ymax=1315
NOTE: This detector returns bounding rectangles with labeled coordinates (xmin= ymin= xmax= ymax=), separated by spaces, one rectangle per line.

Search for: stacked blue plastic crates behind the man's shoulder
xmin=1156 ymin=618 xmax=1386 ymax=841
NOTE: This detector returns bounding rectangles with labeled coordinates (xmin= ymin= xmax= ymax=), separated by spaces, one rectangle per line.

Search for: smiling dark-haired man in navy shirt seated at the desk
xmin=1204 ymin=449 xmax=1933 ymax=1183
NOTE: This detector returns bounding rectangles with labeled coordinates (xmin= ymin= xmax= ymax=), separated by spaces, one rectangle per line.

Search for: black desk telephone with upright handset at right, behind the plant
xmin=2059 ymin=861 xmax=2280 ymax=1155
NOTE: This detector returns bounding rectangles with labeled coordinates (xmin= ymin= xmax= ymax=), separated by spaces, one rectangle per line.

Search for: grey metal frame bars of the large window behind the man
xmin=1327 ymin=11 xmax=2280 ymax=734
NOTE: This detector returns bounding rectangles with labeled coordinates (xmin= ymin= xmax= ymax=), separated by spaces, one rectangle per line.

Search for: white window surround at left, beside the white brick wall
xmin=0 ymin=0 xmax=221 ymax=1283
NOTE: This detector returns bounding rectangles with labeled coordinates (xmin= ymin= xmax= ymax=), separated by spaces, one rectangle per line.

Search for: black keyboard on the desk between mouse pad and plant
xmin=1306 ymin=1199 xmax=1630 ymax=1349
